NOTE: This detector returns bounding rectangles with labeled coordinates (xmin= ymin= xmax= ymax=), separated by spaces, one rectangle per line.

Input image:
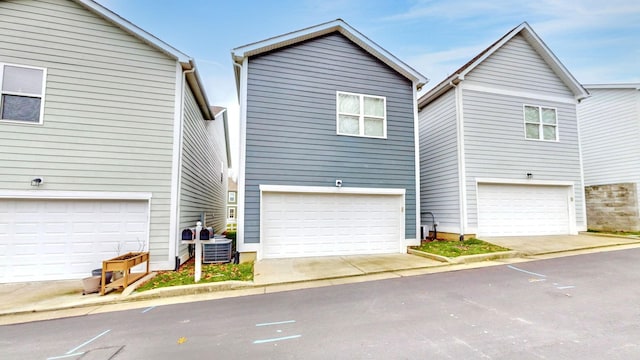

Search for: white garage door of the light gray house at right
xmin=478 ymin=184 xmax=571 ymax=236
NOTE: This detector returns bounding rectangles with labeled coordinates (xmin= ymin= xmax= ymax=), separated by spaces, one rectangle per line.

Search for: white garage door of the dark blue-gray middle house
xmin=261 ymin=192 xmax=404 ymax=258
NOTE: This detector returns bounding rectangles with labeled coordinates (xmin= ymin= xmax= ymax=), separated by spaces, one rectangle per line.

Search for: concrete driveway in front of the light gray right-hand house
xmin=482 ymin=233 xmax=640 ymax=255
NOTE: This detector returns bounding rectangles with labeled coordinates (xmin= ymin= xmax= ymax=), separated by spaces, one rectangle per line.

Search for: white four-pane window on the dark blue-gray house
xmin=337 ymin=91 xmax=387 ymax=138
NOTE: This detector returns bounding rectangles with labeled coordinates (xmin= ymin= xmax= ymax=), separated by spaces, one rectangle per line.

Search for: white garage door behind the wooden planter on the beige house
xmin=0 ymin=199 xmax=148 ymax=283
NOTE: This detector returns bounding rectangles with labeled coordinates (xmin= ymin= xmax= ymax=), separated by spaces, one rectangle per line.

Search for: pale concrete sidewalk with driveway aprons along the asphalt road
xmin=0 ymin=234 xmax=640 ymax=325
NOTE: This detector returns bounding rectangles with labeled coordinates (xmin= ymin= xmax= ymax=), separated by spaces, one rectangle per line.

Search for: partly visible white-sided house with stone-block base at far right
xmin=578 ymin=83 xmax=640 ymax=231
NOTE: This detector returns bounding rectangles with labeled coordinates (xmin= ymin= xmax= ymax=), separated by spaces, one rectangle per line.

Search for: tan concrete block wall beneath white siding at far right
xmin=585 ymin=183 xmax=640 ymax=231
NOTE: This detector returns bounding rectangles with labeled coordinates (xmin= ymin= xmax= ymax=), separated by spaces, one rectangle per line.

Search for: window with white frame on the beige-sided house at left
xmin=0 ymin=63 xmax=46 ymax=124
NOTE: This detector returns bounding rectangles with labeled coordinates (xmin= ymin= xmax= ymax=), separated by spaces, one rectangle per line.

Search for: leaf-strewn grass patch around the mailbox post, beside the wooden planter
xmin=137 ymin=259 xmax=253 ymax=291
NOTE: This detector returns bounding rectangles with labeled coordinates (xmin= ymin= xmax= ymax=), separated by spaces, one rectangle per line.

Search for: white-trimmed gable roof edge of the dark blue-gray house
xmin=231 ymin=19 xmax=429 ymax=91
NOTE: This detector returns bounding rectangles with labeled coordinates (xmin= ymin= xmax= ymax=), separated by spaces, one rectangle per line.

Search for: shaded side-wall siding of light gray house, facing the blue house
xmin=419 ymin=90 xmax=460 ymax=231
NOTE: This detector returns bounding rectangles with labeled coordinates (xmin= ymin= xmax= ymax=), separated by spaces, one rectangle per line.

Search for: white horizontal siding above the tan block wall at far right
xmin=578 ymin=89 xmax=640 ymax=186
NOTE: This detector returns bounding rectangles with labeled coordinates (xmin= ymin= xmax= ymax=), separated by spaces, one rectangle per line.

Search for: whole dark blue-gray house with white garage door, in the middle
xmin=232 ymin=19 xmax=427 ymax=259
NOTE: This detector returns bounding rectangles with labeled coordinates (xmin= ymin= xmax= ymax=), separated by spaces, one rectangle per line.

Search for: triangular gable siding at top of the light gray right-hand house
xmin=465 ymin=35 xmax=573 ymax=99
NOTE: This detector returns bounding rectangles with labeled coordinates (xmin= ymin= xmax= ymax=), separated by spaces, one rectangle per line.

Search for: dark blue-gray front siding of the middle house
xmin=244 ymin=33 xmax=416 ymax=243
